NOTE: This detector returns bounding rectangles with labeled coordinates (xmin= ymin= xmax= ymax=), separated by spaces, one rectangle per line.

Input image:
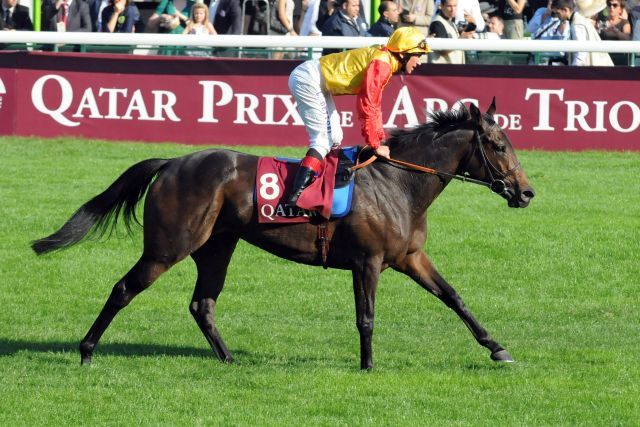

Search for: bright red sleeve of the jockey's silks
xmin=357 ymin=59 xmax=393 ymax=149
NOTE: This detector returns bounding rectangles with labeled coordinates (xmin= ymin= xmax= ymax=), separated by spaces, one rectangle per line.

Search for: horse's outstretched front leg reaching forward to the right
xmin=395 ymin=252 xmax=513 ymax=362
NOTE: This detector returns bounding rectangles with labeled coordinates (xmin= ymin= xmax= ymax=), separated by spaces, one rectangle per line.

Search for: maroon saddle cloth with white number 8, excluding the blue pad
xmin=256 ymin=151 xmax=338 ymax=224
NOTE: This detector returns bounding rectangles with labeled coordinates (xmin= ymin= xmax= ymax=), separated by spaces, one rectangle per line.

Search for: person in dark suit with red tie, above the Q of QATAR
xmin=42 ymin=0 xmax=92 ymax=32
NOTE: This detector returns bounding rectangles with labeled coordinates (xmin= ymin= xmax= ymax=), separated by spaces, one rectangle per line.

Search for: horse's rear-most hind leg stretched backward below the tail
xmin=80 ymin=257 xmax=169 ymax=364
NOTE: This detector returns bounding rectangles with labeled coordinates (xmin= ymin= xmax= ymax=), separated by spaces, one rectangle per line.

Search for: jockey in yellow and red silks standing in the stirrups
xmin=287 ymin=27 xmax=431 ymax=206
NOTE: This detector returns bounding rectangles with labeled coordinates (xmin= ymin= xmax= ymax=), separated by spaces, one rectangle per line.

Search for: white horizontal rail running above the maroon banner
xmin=0 ymin=31 xmax=640 ymax=55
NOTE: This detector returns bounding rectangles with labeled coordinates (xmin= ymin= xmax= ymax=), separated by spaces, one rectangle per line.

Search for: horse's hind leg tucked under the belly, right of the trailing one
xmin=189 ymin=234 xmax=238 ymax=363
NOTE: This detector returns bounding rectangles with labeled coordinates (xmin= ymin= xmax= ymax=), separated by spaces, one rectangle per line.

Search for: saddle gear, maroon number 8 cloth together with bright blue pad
xmin=254 ymin=147 xmax=361 ymax=224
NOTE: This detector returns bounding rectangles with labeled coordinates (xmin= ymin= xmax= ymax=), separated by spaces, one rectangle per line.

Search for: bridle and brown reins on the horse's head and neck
xmin=351 ymin=130 xmax=521 ymax=195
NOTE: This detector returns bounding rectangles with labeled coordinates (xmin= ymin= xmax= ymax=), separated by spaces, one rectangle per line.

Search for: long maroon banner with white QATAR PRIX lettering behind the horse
xmin=0 ymin=52 xmax=640 ymax=150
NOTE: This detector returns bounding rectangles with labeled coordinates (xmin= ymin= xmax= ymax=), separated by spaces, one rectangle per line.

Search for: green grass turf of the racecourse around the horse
xmin=0 ymin=138 xmax=640 ymax=426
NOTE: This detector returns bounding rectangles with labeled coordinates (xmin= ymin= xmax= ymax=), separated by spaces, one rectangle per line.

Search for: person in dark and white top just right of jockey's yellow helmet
xmin=429 ymin=0 xmax=475 ymax=64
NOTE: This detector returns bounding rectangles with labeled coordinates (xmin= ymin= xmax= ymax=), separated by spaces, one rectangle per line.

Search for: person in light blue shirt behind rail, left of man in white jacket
xmin=527 ymin=0 xmax=570 ymax=65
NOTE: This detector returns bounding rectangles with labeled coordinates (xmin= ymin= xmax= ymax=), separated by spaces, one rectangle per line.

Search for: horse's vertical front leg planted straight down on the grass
xmin=352 ymin=258 xmax=381 ymax=369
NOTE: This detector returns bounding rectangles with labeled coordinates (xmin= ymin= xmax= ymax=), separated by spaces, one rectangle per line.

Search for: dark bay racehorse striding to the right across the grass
xmin=32 ymin=99 xmax=534 ymax=369
